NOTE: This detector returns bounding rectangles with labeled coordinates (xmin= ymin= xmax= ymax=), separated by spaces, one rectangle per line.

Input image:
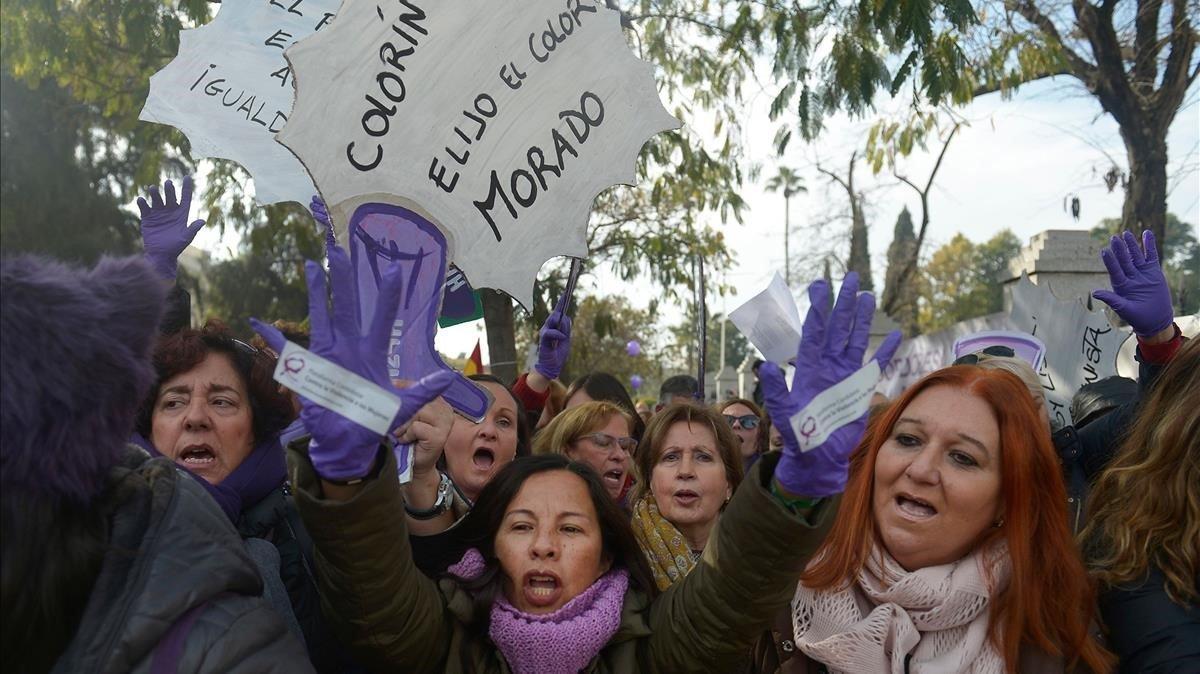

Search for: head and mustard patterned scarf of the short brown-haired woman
xmin=632 ymin=403 xmax=744 ymax=590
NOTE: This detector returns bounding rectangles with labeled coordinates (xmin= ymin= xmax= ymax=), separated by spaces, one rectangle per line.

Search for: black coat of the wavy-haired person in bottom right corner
xmin=1100 ymin=568 xmax=1200 ymax=674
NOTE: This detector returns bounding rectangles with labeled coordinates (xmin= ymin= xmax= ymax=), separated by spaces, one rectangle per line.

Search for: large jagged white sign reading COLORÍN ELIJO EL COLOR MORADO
xmin=277 ymin=0 xmax=679 ymax=307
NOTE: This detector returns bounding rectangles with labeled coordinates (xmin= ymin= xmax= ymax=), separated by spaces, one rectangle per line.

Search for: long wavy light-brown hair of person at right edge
xmin=1080 ymin=339 xmax=1200 ymax=604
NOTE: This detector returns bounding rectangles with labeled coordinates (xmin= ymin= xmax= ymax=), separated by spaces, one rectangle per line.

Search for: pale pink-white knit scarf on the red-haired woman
xmin=792 ymin=543 xmax=1010 ymax=674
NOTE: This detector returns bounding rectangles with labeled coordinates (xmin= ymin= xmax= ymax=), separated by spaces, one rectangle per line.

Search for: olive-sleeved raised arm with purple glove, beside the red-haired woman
xmin=649 ymin=273 xmax=900 ymax=672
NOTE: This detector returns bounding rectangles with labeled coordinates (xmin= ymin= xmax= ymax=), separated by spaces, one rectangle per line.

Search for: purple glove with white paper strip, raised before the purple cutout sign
xmin=250 ymin=239 xmax=454 ymax=481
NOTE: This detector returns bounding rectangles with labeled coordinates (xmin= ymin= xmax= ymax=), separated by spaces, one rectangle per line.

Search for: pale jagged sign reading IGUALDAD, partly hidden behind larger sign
xmin=139 ymin=0 xmax=341 ymax=205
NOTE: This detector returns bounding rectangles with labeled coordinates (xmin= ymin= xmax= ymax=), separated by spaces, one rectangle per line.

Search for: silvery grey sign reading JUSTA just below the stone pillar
xmin=1009 ymin=275 xmax=1126 ymax=425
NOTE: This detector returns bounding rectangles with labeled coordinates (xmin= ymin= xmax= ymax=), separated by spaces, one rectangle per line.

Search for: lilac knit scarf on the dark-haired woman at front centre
xmin=449 ymin=548 xmax=629 ymax=674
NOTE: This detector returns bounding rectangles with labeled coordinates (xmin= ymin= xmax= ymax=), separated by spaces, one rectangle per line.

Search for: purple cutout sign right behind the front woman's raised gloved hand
xmin=349 ymin=204 xmax=492 ymax=421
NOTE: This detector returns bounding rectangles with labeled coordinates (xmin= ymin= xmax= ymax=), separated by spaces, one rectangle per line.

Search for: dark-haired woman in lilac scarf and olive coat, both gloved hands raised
xmin=252 ymin=229 xmax=899 ymax=674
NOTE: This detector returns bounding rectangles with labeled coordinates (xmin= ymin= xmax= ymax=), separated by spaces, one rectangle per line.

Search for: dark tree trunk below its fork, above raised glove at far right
xmin=1121 ymin=124 xmax=1166 ymax=245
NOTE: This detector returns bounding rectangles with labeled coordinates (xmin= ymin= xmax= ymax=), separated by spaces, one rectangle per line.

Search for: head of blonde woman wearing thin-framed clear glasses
xmin=533 ymin=401 xmax=637 ymax=503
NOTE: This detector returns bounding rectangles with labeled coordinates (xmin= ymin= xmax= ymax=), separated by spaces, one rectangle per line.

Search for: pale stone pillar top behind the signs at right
xmin=997 ymin=229 xmax=1109 ymax=313
